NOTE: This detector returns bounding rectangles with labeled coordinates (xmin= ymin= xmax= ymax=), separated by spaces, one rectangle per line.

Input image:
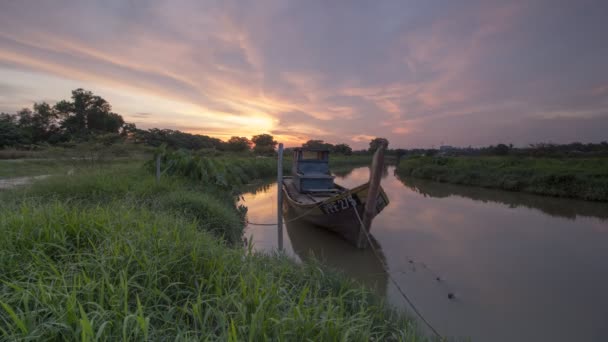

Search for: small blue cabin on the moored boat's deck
xmin=291 ymin=148 xmax=335 ymax=193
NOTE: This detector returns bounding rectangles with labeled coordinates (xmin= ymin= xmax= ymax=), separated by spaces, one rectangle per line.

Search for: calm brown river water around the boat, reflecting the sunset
xmin=244 ymin=167 xmax=608 ymax=341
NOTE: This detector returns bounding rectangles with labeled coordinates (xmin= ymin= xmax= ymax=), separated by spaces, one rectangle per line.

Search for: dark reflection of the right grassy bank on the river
xmin=396 ymin=175 xmax=608 ymax=220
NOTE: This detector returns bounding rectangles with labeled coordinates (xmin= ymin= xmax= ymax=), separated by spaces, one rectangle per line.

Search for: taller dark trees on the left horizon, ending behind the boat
xmin=0 ymin=88 xmax=370 ymax=155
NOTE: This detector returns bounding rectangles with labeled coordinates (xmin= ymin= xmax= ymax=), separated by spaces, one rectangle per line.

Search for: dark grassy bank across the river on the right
xmin=397 ymin=157 xmax=608 ymax=201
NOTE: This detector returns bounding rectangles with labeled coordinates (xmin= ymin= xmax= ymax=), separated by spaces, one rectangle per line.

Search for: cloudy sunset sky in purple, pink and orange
xmin=0 ymin=0 xmax=608 ymax=148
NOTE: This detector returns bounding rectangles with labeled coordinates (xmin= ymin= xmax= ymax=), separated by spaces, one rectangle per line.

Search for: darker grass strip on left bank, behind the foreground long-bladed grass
xmin=6 ymin=163 xmax=246 ymax=245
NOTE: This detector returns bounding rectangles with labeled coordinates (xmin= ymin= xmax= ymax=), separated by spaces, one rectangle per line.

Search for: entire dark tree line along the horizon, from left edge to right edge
xmin=7 ymin=88 xmax=608 ymax=157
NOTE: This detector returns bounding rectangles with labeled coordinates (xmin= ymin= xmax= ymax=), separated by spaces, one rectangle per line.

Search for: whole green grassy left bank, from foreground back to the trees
xmin=0 ymin=161 xmax=425 ymax=341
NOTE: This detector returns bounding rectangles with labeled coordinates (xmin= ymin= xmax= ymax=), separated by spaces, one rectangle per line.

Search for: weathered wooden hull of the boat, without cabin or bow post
xmin=282 ymin=177 xmax=389 ymax=245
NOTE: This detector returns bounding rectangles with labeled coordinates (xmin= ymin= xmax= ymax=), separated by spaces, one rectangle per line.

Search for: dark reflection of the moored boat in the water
xmin=285 ymin=204 xmax=388 ymax=296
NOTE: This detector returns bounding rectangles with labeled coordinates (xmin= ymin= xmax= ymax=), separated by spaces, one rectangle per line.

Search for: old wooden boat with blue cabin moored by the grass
xmin=282 ymin=146 xmax=389 ymax=248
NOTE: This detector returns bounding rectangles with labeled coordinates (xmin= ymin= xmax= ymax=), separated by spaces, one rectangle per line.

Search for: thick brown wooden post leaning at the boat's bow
xmin=357 ymin=143 xmax=387 ymax=248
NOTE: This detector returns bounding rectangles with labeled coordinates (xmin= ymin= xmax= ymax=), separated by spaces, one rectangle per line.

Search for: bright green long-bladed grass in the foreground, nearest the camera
xmin=0 ymin=201 xmax=415 ymax=341
